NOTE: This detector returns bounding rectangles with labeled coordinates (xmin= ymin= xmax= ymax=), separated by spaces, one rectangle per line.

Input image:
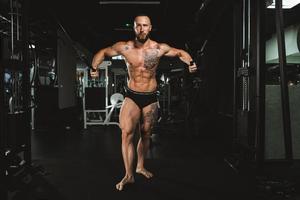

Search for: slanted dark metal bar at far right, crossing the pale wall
xmin=275 ymin=0 xmax=293 ymax=161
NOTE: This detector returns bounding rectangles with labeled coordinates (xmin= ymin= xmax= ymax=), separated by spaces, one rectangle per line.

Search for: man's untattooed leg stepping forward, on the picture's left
xmin=116 ymin=98 xmax=141 ymax=190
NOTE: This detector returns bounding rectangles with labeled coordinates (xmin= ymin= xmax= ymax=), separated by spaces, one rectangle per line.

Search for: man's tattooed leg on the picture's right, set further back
xmin=136 ymin=103 xmax=158 ymax=178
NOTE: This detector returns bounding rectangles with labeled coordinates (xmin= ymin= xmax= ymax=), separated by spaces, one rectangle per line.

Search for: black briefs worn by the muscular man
xmin=125 ymin=87 xmax=158 ymax=109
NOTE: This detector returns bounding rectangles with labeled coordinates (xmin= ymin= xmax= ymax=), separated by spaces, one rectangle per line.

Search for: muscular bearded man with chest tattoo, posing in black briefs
xmin=91 ymin=15 xmax=197 ymax=190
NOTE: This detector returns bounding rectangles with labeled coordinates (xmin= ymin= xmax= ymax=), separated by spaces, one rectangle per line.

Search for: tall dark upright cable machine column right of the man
xmin=233 ymin=0 xmax=265 ymax=168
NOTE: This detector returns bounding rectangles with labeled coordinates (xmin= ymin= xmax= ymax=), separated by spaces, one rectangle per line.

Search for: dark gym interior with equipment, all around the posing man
xmin=0 ymin=0 xmax=300 ymax=200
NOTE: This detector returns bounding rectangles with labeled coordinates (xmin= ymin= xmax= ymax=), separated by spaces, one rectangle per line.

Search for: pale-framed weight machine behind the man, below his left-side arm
xmin=79 ymin=61 xmax=124 ymax=129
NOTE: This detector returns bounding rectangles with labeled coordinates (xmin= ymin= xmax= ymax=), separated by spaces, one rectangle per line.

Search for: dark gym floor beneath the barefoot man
xmin=11 ymin=122 xmax=299 ymax=200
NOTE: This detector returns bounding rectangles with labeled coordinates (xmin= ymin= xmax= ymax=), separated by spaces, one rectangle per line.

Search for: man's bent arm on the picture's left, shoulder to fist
xmin=92 ymin=42 xmax=126 ymax=71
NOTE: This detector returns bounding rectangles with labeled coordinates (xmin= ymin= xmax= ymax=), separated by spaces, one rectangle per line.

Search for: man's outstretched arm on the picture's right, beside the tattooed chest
xmin=161 ymin=44 xmax=197 ymax=73
